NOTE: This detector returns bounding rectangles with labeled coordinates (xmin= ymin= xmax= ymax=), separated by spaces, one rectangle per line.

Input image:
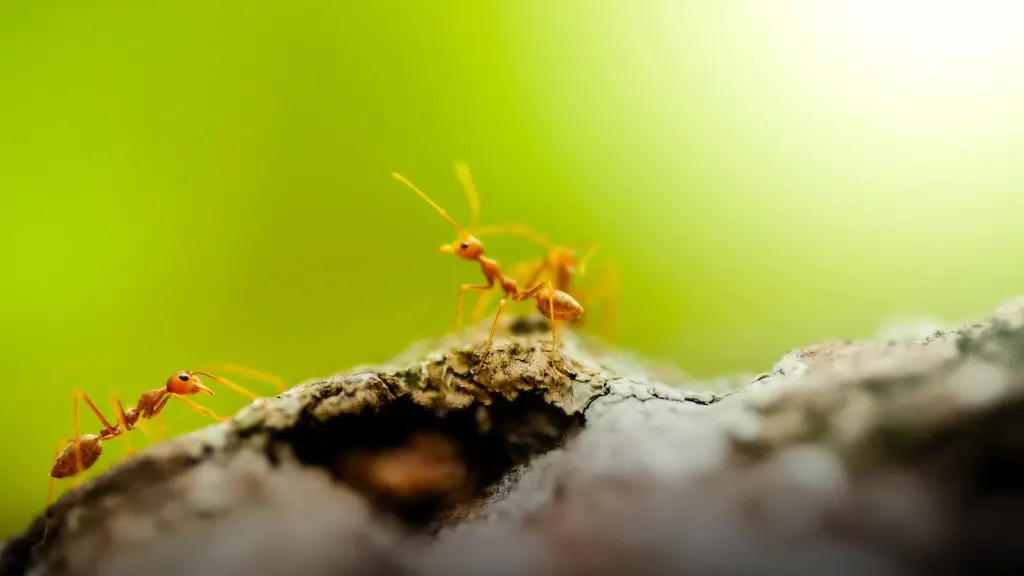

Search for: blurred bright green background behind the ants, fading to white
xmin=0 ymin=0 xmax=1024 ymax=535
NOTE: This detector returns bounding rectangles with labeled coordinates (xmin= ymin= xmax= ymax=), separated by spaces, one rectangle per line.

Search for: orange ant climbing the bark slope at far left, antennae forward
xmin=46 ymin=364 xmax=284 ymax=505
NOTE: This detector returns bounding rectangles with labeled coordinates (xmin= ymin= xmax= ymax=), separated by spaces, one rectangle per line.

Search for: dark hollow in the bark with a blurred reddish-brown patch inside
xmin=271 ymin=394 xmax=580 ymax=529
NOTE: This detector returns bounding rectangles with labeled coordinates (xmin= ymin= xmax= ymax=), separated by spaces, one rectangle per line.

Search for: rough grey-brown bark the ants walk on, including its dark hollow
xmin=0 ymin=301 xmax=1024 ymax=575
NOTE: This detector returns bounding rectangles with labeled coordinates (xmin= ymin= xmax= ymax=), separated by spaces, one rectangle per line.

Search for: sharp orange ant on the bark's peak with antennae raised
xmin=391 ymin=163 xmax=584 ymax=353
